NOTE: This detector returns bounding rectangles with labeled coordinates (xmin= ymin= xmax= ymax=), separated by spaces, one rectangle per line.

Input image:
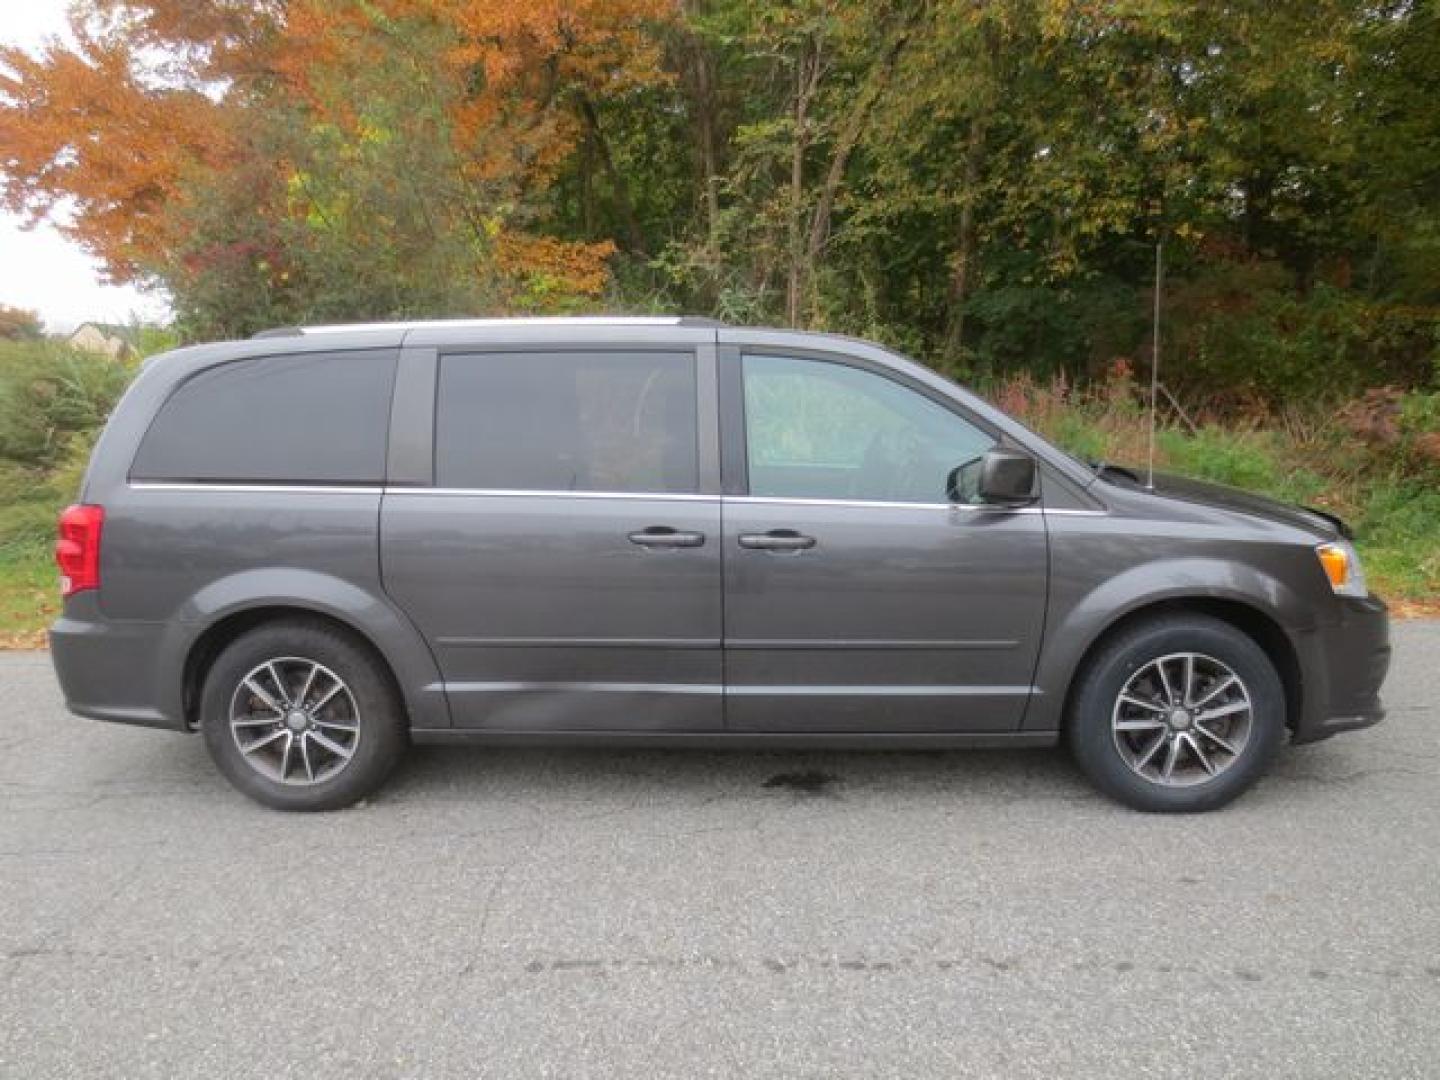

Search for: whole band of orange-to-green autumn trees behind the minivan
xmin=0 ymin=0 xmax=1440 ymax=402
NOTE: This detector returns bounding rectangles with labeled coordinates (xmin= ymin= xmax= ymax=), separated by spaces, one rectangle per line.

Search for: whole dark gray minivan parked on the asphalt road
xmin=50 ymin=318 xmax=1390 ymax=811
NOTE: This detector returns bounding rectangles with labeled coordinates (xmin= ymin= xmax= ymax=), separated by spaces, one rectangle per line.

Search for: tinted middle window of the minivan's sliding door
xmin=435 ymin=353 xmax=698 ymax=492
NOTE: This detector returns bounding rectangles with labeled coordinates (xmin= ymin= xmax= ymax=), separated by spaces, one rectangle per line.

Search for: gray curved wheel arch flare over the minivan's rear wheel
xmin=157 ymin=567 xmax=451 ymax=727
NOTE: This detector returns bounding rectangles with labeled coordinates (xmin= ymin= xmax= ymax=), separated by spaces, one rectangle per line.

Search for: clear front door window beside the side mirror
xmin=742 ymin=356 xmax=995 ymax=504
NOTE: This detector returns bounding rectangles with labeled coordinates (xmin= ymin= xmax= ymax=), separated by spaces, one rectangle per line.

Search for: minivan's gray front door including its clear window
xmin=721 ymin=350 xmax=1047 ymax=733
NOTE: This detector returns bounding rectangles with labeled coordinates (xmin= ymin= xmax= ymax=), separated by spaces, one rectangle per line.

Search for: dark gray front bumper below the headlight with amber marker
xmin=1295 ymin=596 xmax=1390 ymax=743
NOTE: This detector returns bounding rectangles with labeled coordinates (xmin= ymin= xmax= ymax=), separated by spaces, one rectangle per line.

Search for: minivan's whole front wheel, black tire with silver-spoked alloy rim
xmin=1067 ymin=615 xmax=1286 ymax=814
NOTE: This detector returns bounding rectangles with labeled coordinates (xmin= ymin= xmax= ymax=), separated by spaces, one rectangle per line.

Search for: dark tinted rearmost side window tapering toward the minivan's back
xmin=130 ymin=350 xmax=396 ymax=484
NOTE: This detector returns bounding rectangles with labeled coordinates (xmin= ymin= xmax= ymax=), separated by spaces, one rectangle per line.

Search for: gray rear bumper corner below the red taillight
xmin=50 ymin=596 xmax=184 ymax=732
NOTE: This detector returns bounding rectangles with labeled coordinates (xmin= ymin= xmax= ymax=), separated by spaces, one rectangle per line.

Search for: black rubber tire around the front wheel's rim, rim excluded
xmin=1070 ymin=616 xmax=1286 ymax=812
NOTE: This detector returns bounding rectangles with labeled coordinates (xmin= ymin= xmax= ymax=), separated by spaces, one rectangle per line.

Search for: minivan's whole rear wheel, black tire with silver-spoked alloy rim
xmin=200 ymin=619 xmax=409 ymax=811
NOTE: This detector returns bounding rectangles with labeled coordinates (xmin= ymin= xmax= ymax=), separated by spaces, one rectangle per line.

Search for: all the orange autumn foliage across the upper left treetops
xmin=0 ymin=0 xmax=677 ymax=297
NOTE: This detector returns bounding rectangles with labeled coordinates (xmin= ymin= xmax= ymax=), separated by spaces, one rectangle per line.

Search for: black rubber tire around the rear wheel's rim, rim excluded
xmin=200 ymin=624 xmax=405 ymax=811
